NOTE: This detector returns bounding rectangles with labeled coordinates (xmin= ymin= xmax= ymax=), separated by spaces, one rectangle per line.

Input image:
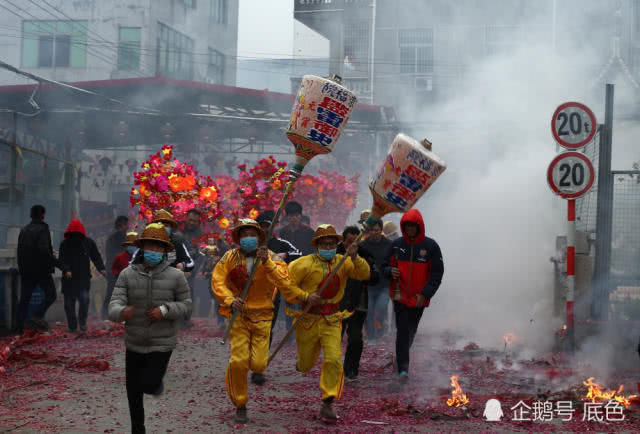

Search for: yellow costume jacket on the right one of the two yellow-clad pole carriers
xmin=286 ymin=253 xmax=371 ymax=318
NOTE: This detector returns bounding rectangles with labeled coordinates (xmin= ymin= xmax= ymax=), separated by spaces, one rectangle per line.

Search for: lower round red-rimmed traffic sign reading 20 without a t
xmin=547 ymin=151 xmax=596 ymax=199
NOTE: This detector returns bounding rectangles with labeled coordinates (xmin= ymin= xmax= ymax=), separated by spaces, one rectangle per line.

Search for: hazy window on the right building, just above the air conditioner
xmin=398 ymin=29 xmax=433 ymax=74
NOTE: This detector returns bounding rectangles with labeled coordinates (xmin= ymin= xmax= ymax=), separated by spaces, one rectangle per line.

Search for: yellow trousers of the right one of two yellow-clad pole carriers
xmin=296 ymin=315 xmax=344 ymax=399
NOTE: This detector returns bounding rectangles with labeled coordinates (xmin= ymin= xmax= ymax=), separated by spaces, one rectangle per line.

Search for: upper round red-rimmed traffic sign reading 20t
xmin=551 ymin=102 xmax=598 ymax=149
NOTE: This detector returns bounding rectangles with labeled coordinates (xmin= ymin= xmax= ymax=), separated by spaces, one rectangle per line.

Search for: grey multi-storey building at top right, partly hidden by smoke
xmin=294 ymin=0 xmax=640 ymax=120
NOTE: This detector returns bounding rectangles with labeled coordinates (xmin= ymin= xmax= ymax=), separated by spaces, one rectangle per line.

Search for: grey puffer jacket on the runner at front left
xmin=109 ymin=261 xmax=191 ymax=353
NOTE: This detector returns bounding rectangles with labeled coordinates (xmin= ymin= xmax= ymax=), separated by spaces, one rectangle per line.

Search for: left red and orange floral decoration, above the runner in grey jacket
xmin=130 ymin=145 xmax=222 ymax=224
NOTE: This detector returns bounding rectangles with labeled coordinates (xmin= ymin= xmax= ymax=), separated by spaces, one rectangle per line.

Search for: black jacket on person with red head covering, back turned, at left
xmin=60 ymin=237 xmax=105 ymax=292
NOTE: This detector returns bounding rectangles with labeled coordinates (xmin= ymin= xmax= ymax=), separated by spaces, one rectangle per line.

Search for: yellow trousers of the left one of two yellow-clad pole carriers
xmin=225 ymin=315 xmax=271 ymax=408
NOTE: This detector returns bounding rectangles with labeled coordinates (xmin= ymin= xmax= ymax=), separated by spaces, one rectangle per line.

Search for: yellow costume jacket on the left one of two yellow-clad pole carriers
xmin=211 ymin=248 xmax=309 ymax=320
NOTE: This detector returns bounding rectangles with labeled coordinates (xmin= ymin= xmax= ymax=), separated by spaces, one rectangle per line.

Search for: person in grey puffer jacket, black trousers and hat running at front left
xmin=109 ymin=223 xmax=191 ymax=434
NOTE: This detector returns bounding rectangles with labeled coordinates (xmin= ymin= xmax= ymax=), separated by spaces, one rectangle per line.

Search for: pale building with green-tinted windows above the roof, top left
xmin=0 ymin=0 xmax=238 ymax=86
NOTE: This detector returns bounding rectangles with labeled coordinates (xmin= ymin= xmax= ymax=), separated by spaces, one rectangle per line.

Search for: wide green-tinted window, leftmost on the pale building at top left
xmin=22 ymin=20 xmax=87 ymax=68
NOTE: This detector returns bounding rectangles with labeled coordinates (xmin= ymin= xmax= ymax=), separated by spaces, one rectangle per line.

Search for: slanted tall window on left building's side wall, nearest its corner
xmin=157 ymin=23 xmax=195 ymax=80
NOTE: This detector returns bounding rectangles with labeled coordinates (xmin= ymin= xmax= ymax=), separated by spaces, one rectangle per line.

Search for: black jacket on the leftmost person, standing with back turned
xmin=18 ymin=221 xmax=68 ymax=277
